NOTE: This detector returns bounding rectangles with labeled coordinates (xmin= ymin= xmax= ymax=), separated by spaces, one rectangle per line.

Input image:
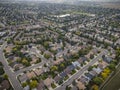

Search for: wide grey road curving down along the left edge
xmin=0 ymin=42 xmax=23 ymax=90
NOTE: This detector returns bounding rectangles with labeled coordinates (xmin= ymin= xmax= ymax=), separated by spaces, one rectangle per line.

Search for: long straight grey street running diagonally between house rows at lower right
xmin=55 ymin=50 xmax=108 ymax=90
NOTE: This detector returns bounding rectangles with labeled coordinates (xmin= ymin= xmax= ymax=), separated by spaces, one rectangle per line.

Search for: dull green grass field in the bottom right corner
xmin=102 ymin=65 xmax=120 ymax=90
